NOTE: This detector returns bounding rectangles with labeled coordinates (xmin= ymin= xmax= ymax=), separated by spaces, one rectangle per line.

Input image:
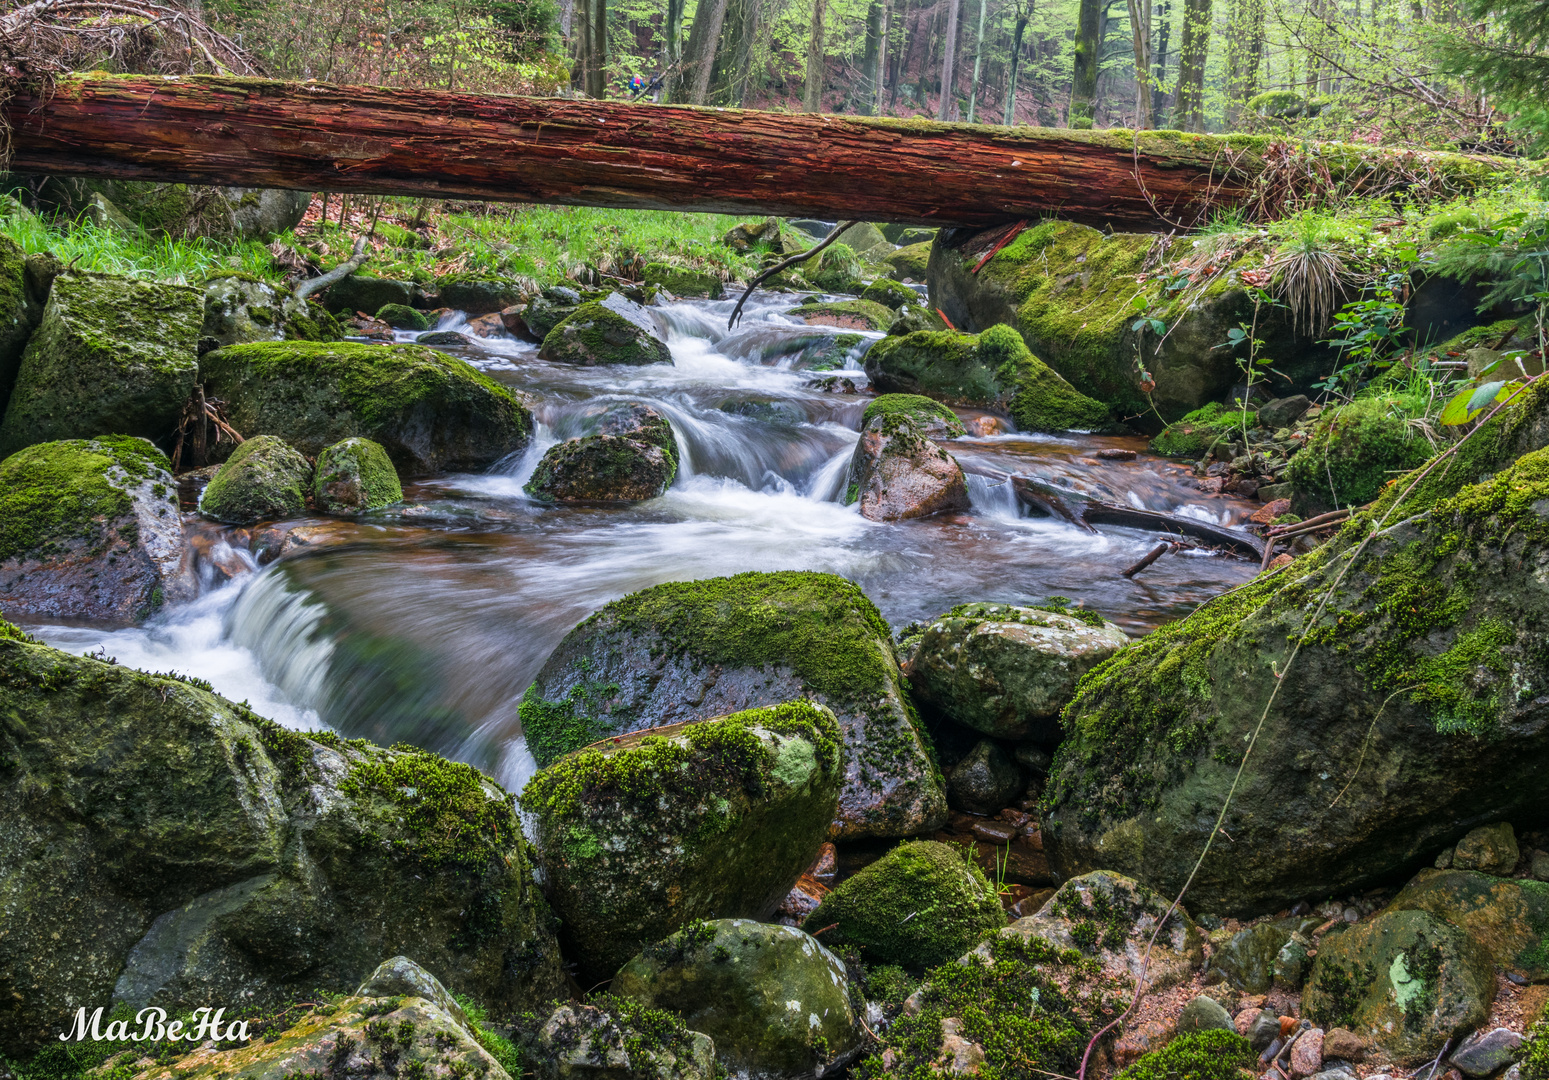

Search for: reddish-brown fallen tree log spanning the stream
xmin=3 ymin=74 xmax=1504 ymax=229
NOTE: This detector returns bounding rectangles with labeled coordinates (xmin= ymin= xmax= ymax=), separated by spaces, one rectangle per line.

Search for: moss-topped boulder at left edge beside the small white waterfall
xmin=0 ymin=435 xmax=197 ymax=623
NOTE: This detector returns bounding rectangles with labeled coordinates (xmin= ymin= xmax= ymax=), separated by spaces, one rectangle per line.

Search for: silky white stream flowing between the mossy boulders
xmin=28 ymin=294 xmax=1256 ymax=790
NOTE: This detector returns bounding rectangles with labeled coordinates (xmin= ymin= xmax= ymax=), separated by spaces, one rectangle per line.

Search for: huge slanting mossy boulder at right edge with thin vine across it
xmin=1044 ymin=390 xmax=1549 ymax=914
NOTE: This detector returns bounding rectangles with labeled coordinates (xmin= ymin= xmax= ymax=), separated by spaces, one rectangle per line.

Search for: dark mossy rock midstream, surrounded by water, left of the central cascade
xmin=527 ymin=401 xmax=678 ymax=502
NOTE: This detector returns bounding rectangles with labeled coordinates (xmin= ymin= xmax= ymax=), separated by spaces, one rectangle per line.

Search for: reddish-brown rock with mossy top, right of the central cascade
xmin=844 ymin=395 xmax=970 ymax=521
